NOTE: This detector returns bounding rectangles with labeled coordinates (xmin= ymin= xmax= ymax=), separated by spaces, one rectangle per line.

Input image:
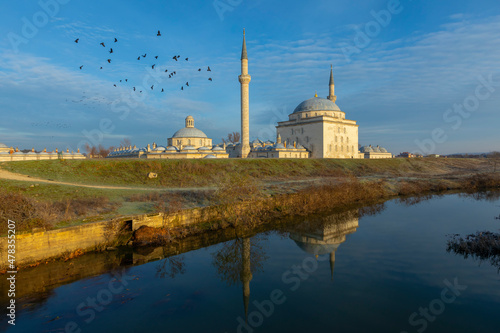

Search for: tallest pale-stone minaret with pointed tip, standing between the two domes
xmin=238 ymin=29 xmax=251 ymax=158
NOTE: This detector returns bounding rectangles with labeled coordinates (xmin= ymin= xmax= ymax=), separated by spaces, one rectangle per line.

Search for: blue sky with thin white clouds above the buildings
xmin=0 ymin=0 xmax=500 ymax=154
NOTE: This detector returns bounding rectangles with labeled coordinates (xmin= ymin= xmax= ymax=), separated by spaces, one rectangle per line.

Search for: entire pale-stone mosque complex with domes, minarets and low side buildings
xmin=0 ymin=31 xmax=386 ymax=161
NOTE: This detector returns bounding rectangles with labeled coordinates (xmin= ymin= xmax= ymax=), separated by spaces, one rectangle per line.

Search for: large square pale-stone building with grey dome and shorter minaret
xmin=276 ymin=69 xmax=363 ymax=158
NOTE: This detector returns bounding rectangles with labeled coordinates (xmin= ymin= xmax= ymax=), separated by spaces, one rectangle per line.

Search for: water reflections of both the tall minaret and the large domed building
xmin=212 ymin=210 xmax=359 ymax=317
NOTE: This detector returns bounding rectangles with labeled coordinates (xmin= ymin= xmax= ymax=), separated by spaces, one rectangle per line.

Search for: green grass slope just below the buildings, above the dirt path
xmin=0 ymin=158 xmax=485 ymax=187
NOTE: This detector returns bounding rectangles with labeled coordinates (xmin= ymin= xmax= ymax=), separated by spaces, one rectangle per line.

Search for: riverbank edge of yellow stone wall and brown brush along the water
xmin=0 ymin=169 xmax=500 ymax=267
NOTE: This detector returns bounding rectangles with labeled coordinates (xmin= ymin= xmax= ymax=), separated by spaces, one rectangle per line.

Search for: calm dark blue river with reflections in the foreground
xmin=0 ymin=194 xmax=500 ymax=333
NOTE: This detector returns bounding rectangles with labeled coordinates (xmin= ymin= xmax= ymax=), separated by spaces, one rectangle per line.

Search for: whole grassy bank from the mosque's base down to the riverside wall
xmin=0 ymin=159 xmax=492 ymax=234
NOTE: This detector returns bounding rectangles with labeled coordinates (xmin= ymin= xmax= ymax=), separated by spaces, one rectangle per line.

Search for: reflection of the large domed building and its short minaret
xmin=290 ymin=209 xmax=359 ymax=280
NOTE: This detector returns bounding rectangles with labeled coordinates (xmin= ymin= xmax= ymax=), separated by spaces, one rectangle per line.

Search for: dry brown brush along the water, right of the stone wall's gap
xmin=134 ymin=174 xmax=500 ymax=246
